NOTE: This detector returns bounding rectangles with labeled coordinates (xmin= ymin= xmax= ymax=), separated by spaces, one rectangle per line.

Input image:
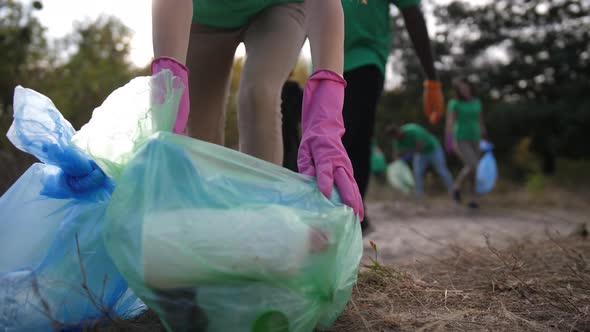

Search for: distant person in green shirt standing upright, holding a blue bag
xmin=445 ymin=79 xmax=487 ymax=208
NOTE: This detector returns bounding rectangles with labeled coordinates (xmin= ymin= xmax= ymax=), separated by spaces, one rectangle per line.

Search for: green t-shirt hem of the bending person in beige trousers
xmin=193 ymin=0 xmax=303 ymax=29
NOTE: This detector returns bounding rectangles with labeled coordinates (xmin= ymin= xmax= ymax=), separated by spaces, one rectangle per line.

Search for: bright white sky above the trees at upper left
xmin=20 ymin=0 xmax=485 ymax=70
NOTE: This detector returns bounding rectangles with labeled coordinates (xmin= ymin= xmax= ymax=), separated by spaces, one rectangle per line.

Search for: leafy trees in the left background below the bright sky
xmin=0 ymin=9 xmax=146 ymax=193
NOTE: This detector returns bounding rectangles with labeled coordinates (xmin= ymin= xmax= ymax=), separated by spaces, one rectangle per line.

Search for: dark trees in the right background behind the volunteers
xmin=378 ymin=0 xmax=590 ymax=171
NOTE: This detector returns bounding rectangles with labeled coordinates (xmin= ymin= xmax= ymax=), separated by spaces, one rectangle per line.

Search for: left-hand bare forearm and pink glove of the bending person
xmin=152 ymin=0 xmax=193 ymax=134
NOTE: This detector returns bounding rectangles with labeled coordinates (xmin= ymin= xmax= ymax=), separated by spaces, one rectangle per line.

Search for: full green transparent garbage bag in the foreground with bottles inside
xmin=105 ymin=132 xmax=362 ymax=331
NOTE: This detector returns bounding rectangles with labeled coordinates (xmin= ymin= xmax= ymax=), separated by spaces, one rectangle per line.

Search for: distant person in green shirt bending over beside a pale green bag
xmin=386 ymin=123 xmax=453 ymax=197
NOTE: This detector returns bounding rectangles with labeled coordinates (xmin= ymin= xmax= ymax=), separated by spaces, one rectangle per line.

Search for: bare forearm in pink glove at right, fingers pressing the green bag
xmin=297 ymin=0 xmax=364 ymax=220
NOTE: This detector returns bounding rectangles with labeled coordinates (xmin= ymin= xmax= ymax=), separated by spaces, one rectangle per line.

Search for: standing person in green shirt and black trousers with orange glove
xmin=342 ymin=0 xmax=444 ymax=230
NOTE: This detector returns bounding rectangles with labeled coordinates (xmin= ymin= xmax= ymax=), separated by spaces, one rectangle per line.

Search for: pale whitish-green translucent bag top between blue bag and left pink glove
xmin=72 ymin=70 xmax=184 ymax=181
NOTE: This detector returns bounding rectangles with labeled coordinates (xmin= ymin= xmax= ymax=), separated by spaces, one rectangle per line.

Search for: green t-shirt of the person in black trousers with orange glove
xmin=342 ymin=0 xmax=420 ymax=75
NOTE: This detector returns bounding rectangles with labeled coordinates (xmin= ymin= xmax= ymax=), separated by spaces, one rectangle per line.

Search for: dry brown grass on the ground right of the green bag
xmin=333 ymin=232 xmax=590 ymax=332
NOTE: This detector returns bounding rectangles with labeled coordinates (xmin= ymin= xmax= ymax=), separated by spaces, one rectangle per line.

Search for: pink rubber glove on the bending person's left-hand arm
xmin=152 ymin=57 xmax=190 ymax=135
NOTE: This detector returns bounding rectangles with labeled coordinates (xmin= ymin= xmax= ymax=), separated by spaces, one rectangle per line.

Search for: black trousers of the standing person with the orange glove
xmin=342 ymin=65 xmax=385 ymax=199
